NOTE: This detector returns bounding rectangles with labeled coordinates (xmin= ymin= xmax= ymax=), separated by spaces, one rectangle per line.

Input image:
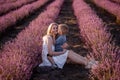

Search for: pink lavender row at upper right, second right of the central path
xmin=93 ymin=0 xmax=120 ymax=24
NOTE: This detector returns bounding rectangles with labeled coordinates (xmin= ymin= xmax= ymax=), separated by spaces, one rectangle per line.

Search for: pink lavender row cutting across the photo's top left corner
xmin=0 ymin=0 xmax=35 ymax=15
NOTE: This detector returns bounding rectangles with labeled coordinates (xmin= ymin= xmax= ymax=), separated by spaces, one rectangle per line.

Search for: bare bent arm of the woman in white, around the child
xmin=48 ymin=37 xmax=66 ymax=56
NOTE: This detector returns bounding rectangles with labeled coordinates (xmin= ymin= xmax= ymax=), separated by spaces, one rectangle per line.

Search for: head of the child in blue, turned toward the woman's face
xmin=58 ymin=24 xmax=69 ymax=35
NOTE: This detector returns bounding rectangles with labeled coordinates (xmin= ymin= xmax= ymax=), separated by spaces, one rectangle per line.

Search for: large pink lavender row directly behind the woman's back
xmin=0 ymin=0 xmax=63 ymax=80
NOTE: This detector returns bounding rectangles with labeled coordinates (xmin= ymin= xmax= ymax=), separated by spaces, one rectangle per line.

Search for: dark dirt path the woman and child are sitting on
xmin=31 ymin=0 xmax=89 ymax=80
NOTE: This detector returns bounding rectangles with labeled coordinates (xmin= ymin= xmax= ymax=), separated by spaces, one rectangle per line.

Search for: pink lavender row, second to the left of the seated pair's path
xmin=0 ymin=0 xmax=48 ymax=32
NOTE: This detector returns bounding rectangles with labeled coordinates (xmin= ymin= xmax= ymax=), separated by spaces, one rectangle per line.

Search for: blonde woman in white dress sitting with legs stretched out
xmin=39 ymin=23 xmax=96 ymax=69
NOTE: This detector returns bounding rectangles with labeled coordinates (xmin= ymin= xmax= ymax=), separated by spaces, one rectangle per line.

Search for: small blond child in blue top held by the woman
xmin=47 ymin=24 xmax=69 ymax=67
